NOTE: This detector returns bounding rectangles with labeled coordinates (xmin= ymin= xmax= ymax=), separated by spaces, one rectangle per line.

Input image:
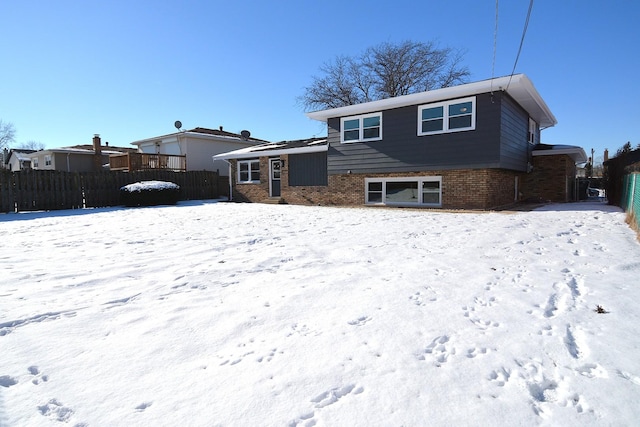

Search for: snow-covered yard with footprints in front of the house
xmin=0 ymin=202 xmax=640 ymax=426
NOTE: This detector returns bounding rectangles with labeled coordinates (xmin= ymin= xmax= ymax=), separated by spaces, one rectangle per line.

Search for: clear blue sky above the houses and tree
xmin=0 ymin=0 xmax=640 ymax=164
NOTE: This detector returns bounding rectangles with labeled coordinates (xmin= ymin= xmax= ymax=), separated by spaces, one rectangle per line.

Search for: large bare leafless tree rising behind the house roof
xmin=299 ymin=41 xmax=470 ymax=110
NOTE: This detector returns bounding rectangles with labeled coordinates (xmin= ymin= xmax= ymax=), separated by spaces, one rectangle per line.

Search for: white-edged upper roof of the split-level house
xmin=307 ymin=74 xmax=558 ymax=128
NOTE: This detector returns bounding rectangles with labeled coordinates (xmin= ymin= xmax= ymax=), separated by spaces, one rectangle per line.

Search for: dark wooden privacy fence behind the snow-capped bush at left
xmin=0 ymin=170 xmax=229 ymax=213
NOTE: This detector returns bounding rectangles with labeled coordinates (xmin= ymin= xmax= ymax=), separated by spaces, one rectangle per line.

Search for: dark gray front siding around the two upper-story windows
xmin=328 ymin=92 xmax=504 ymax=174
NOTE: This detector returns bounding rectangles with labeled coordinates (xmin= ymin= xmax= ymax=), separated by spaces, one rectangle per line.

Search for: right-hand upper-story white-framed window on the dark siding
xmin=418 ymin=97 xmax=476 ymax=136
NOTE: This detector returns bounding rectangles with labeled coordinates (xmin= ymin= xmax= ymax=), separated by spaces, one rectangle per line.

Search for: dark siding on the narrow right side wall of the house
xmin=500 ymin=95 xmax=532 ymax=172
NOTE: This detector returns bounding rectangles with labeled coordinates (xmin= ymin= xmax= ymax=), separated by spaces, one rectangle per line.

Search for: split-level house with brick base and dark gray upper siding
xmin=214 ymin=74 xmax=586 ymax=209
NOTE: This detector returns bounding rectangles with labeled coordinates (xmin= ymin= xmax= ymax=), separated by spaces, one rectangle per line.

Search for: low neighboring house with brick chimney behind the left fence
xmin=29 ymin=135 xmax=133 ymax=172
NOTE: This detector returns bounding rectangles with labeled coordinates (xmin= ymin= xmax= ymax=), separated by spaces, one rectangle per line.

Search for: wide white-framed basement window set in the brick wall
xmin=365 ymin=176 xmax=442 ymax=207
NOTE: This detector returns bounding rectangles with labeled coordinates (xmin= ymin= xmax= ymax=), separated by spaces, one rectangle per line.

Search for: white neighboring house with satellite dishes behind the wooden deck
xmin=122 ymin=126 xmax=267 ymax=176
